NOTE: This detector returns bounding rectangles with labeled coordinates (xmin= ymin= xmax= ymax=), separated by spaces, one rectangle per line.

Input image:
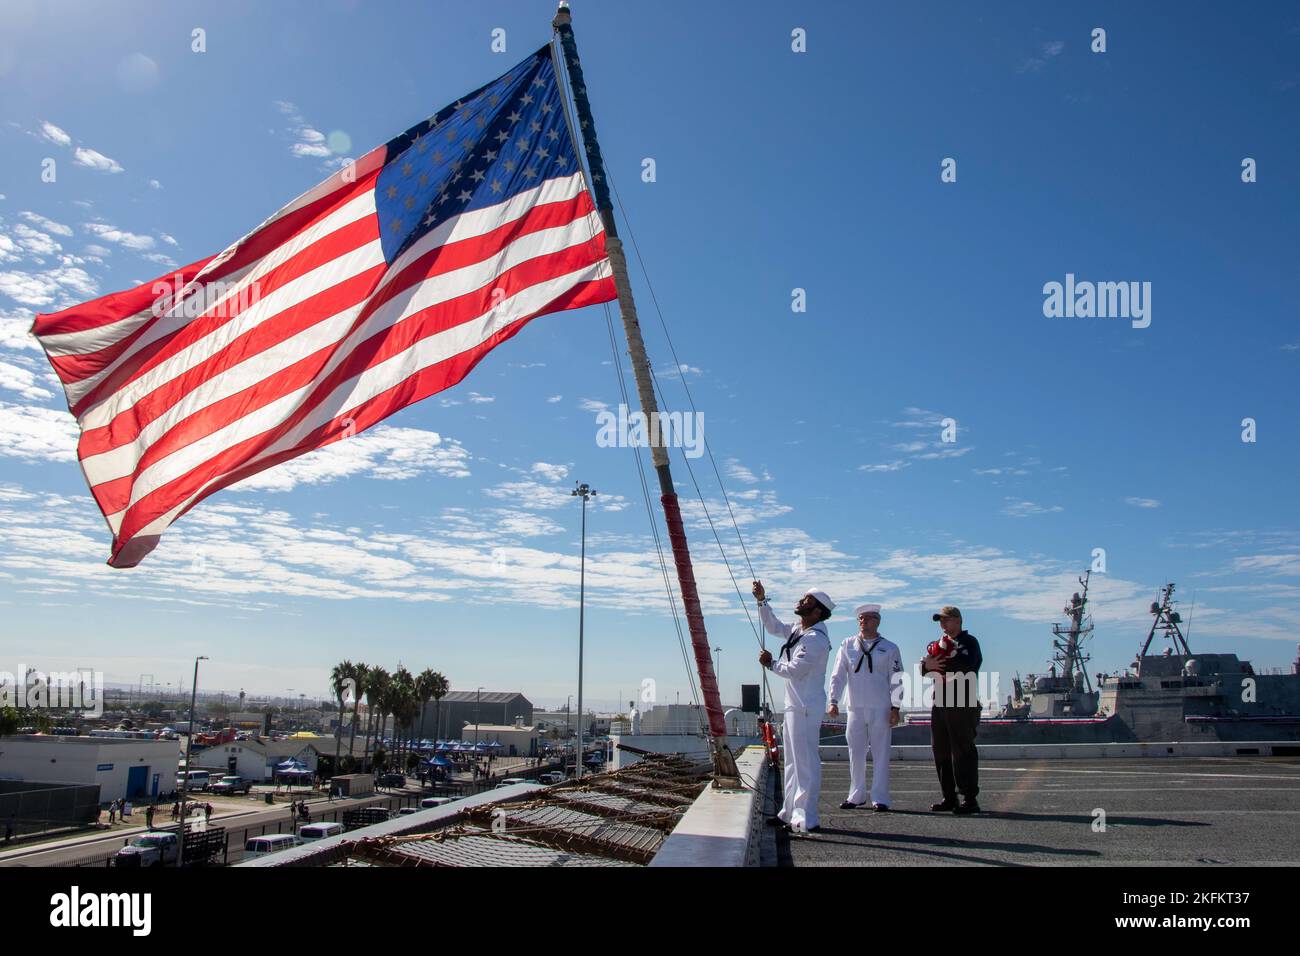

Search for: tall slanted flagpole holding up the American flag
xmin=551 ymin=0 xmax=741 ymax=788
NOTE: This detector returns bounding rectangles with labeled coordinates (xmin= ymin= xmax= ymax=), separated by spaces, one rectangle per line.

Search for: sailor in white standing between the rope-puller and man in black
xmin=829 ymin=604 xmax=904 ymax=810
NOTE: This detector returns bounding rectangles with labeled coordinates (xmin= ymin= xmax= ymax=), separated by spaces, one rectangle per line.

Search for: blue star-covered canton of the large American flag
xmin=374 ymin=47 xmax=579 ymax=263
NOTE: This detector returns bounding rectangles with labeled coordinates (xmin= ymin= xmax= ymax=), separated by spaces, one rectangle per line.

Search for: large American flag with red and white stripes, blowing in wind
xmin=33 ymin=47 xmax=615 ymax=567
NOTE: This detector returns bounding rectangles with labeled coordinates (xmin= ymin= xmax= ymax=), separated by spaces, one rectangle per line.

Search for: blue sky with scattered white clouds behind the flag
xmin=0 ymin=3 xmax=1300 ymax=706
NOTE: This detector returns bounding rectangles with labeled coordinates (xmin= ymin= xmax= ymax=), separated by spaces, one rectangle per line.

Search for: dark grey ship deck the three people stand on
xmin=762 ymin=757 xmax=1300 ymax=868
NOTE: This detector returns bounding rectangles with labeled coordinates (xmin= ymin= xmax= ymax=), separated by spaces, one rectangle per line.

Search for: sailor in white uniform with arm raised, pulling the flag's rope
xmin=754 ymin=581 xmax=835 ymax=831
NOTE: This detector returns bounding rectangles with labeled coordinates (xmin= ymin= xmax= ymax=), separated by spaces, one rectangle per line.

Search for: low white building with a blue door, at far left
xmin=0 ymin=734 xmax=179 ymax=803
